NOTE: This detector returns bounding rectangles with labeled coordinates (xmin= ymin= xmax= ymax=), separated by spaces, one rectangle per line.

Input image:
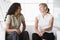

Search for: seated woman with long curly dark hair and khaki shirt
xmin=5 ymin=3 xmax=29 ymax=40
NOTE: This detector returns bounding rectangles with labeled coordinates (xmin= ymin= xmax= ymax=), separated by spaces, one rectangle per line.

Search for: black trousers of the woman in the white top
xmin=32 ymin=32 xmax=55 ymax=40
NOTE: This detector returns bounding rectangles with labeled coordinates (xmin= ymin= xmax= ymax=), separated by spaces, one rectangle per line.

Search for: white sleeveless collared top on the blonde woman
xmin=37 ymin=14 xmax=53 ymax=32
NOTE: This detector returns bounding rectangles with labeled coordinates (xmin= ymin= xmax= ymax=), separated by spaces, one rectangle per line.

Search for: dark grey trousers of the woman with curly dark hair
xmin=6 ymin=31 xmax=29 ymax=40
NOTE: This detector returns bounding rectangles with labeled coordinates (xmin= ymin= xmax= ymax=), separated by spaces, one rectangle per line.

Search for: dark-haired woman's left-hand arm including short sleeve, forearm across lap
xmin=6 ymin=15 xmax=20 ymax=33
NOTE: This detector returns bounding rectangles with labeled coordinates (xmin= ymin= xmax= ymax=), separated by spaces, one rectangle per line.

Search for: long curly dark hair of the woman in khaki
xmin=4 ymin=3 xmax=21 ymax=21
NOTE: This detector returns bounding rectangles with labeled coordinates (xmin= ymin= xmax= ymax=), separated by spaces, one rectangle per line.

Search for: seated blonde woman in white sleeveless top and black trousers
xmin=32 ymin=3 xmax=54 ymax=40
